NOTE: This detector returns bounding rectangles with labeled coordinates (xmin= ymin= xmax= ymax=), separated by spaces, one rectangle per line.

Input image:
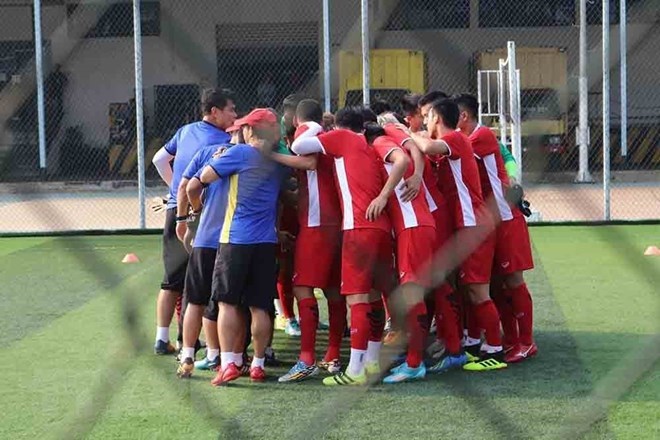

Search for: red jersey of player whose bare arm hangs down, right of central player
xmin=373 ymin=136 xmax=435 ymax=236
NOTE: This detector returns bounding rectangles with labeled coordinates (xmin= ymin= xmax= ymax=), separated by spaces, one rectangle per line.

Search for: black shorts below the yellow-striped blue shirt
xmin=213 ymin=243 xmax=277 ymax=311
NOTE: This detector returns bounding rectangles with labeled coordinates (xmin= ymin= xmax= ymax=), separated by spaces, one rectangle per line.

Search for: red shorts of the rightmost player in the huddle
xmin=493 ymin=215 xmax=534 ymax=275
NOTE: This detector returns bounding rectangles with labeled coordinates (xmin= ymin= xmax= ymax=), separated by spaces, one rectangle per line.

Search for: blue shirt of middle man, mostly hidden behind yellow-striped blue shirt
xmin=183 ymin=144 xmax=232 ymax=249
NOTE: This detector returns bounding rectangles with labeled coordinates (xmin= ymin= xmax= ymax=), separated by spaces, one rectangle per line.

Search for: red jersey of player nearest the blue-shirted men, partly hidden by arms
xmin=294 ymin=122 xmax=341 ymax=228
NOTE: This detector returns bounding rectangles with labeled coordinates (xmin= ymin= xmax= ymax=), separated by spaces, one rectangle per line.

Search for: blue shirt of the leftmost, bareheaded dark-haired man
xmin=165 ymin=121 xmax=231 ymax=208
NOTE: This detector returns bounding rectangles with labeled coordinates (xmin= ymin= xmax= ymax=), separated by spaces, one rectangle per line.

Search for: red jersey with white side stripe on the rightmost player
xmin=470 ymin=125 xmax=522 ymax=222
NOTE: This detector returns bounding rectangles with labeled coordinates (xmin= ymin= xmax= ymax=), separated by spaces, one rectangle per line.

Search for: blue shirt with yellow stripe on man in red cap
xmin=209 ymin=144 xmax=288 ymax=244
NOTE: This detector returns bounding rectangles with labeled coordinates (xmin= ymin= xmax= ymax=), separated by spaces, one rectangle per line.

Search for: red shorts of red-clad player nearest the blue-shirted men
xmin=293 ymin=226 xmax=341 ymax=289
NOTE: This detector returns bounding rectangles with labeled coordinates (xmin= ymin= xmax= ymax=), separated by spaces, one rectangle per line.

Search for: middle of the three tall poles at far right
xmin=603 ymin=0 xmax=611 ymax=221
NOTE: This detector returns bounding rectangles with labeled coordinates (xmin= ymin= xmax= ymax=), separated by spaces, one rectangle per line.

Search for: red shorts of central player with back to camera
xmin=341 ymin=228 xmax=394 ymax=295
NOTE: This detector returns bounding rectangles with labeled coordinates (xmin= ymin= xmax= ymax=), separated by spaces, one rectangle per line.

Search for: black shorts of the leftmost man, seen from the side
xmin=160 ymin=208 xmax=188 ymax=293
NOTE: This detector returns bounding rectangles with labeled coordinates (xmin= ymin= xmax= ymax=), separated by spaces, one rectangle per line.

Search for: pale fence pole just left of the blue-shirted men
xmin=133 ymin=0 xmax=146 ymax=229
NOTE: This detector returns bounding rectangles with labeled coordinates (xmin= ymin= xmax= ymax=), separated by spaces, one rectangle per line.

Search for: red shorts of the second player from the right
xmin=457 ymin=226 xmax=495 ymax=285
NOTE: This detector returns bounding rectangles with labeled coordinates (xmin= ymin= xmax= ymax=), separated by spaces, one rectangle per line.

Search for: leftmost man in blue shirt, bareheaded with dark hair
xmin=153 ymin=89 xmax=236 ymax=354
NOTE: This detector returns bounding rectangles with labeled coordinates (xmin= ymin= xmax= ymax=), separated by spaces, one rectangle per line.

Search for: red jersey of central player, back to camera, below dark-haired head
xmin=318 ymin=129 xmax=392 ymax=233
